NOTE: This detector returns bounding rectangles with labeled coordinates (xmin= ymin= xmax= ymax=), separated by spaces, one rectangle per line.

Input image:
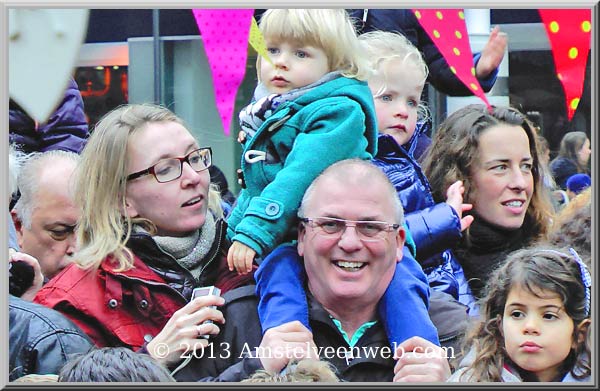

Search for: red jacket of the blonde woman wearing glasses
xmin=34 ymin=222 xmax=253 ymax=350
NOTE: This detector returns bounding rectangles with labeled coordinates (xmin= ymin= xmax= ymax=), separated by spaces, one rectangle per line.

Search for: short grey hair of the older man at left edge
xmin=15 ymin=150 xmax=80 ymax=229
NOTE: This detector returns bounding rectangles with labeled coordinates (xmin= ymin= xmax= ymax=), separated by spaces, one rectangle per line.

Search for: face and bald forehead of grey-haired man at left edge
xmin=13 ymin=164 xmax=80 ymax=278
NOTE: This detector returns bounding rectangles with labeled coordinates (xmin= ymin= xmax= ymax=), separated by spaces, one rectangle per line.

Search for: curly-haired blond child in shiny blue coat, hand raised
xmin=359 ymin=31 xmax=473 ymax=302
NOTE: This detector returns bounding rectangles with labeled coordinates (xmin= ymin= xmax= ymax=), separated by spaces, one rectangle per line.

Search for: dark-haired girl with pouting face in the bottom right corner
xmin=448 ymin=245 xmax=591 ymax=382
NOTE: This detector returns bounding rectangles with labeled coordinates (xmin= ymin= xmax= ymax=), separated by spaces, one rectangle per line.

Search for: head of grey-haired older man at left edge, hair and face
xmin=11 ymin=150 xmax=80 ymax=281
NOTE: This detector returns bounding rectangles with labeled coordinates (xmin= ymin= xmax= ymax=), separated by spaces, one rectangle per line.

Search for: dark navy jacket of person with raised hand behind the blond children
xmin=348 ymin=8 xmax=498 ymax=96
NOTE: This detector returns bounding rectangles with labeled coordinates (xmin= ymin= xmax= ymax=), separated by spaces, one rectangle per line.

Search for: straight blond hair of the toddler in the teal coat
xmin=256 ymin=9 xmax=369 ymax=81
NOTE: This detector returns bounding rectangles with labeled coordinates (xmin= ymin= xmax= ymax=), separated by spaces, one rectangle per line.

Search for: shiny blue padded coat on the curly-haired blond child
xmin=373 ymin=123 xmax=466 ymax=299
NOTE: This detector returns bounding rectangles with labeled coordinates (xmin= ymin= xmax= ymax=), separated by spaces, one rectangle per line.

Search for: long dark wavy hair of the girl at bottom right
xmin=459 ymin=244 xmax=591 ymax=382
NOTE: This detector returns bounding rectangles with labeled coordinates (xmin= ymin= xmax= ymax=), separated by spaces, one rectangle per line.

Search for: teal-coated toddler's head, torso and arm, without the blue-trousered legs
xmin=227 ymin=9 xmax=377 ymax=274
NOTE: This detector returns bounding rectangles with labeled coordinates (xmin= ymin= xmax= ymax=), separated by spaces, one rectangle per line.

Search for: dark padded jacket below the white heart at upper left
xmin=8 ymin=78 xmax=89 ymax=153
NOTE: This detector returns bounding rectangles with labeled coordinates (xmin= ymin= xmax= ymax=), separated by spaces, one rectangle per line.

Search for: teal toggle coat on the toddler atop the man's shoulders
xmin=227 ymin=77 xmax=377 ymax=256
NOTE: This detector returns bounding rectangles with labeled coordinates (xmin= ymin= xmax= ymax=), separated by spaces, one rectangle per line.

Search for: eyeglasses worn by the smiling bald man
xmin=300 ymin=217 xmax=400 ymax=242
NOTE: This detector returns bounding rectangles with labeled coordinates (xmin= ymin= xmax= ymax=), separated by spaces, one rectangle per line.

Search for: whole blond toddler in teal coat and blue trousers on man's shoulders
xmin=228 ymin=9 xmax=439 ymax=352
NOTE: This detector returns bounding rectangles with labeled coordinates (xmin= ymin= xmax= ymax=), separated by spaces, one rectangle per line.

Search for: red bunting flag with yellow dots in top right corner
xmin=538 ymin=9 xmax=592 ymax=121
